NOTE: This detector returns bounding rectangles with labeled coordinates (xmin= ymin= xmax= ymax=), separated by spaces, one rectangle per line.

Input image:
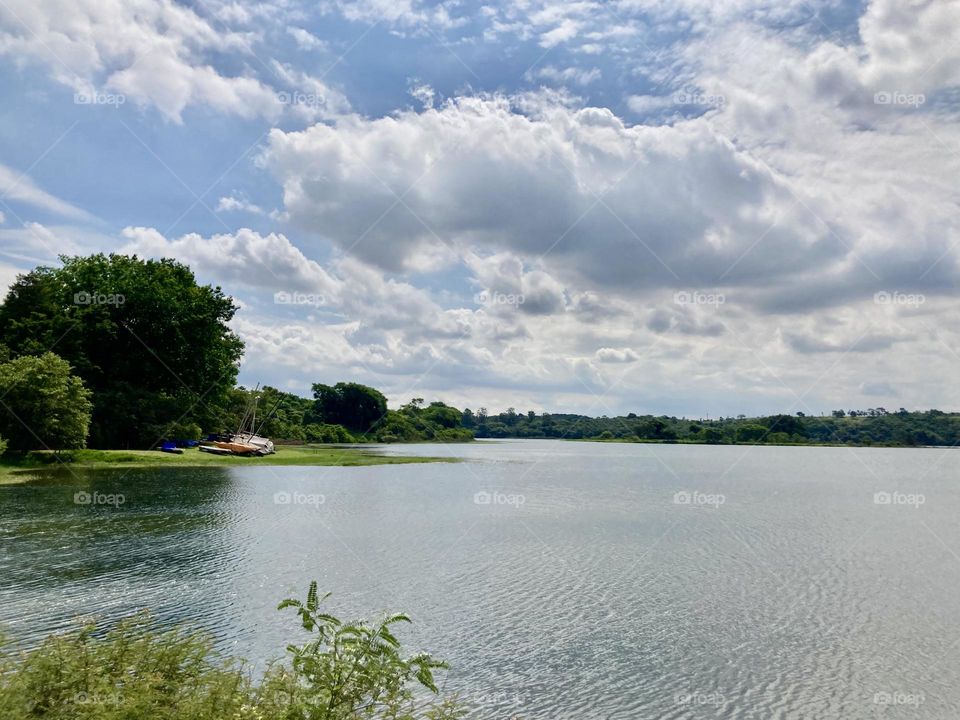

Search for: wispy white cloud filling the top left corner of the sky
xmin=0 ymin=0 xmax=348 ymax=123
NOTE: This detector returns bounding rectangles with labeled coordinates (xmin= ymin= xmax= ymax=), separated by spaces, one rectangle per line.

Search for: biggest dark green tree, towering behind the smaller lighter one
xmin=0 ymin=254 xmax=243 ymax=447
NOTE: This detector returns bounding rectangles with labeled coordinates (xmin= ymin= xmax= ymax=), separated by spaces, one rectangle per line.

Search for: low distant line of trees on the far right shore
xmin=463 ymin=408 xmax=960 ymax=446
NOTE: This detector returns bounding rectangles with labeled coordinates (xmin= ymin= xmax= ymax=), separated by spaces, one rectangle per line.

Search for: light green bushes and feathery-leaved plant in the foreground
xmin=0 ymin=582 xmax=464 ymax=720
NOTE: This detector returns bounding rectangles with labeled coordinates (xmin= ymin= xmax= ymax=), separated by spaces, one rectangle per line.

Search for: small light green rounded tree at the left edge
xmin=0 ymin=352 xmax=93 ymax=452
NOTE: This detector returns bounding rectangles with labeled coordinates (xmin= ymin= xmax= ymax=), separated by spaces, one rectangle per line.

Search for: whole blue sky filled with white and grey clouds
xmin=0 ymin=0 xmax=960 ymax=417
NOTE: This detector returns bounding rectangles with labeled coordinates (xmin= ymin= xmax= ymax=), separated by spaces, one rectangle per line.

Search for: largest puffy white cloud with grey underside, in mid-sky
xmin=263 ymin=97 xmax=849 ymax=304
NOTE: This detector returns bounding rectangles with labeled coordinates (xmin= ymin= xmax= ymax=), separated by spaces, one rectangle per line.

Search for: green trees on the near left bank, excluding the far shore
xmin=0 ymin=254 xmax=472 ymax=453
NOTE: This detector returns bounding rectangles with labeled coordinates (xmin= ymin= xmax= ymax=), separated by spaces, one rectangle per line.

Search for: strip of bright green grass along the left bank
xmin=0 ymin=445 xmax=457 ymax=484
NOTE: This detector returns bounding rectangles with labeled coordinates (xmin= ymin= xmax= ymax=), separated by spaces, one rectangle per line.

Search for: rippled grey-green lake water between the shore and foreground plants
xmin=0 ymin=441 xmax=960 ymax=720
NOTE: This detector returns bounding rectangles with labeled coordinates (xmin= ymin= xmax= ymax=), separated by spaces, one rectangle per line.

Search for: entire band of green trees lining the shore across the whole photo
xmin=0 ymin=254 xmax=960 ymax=452
